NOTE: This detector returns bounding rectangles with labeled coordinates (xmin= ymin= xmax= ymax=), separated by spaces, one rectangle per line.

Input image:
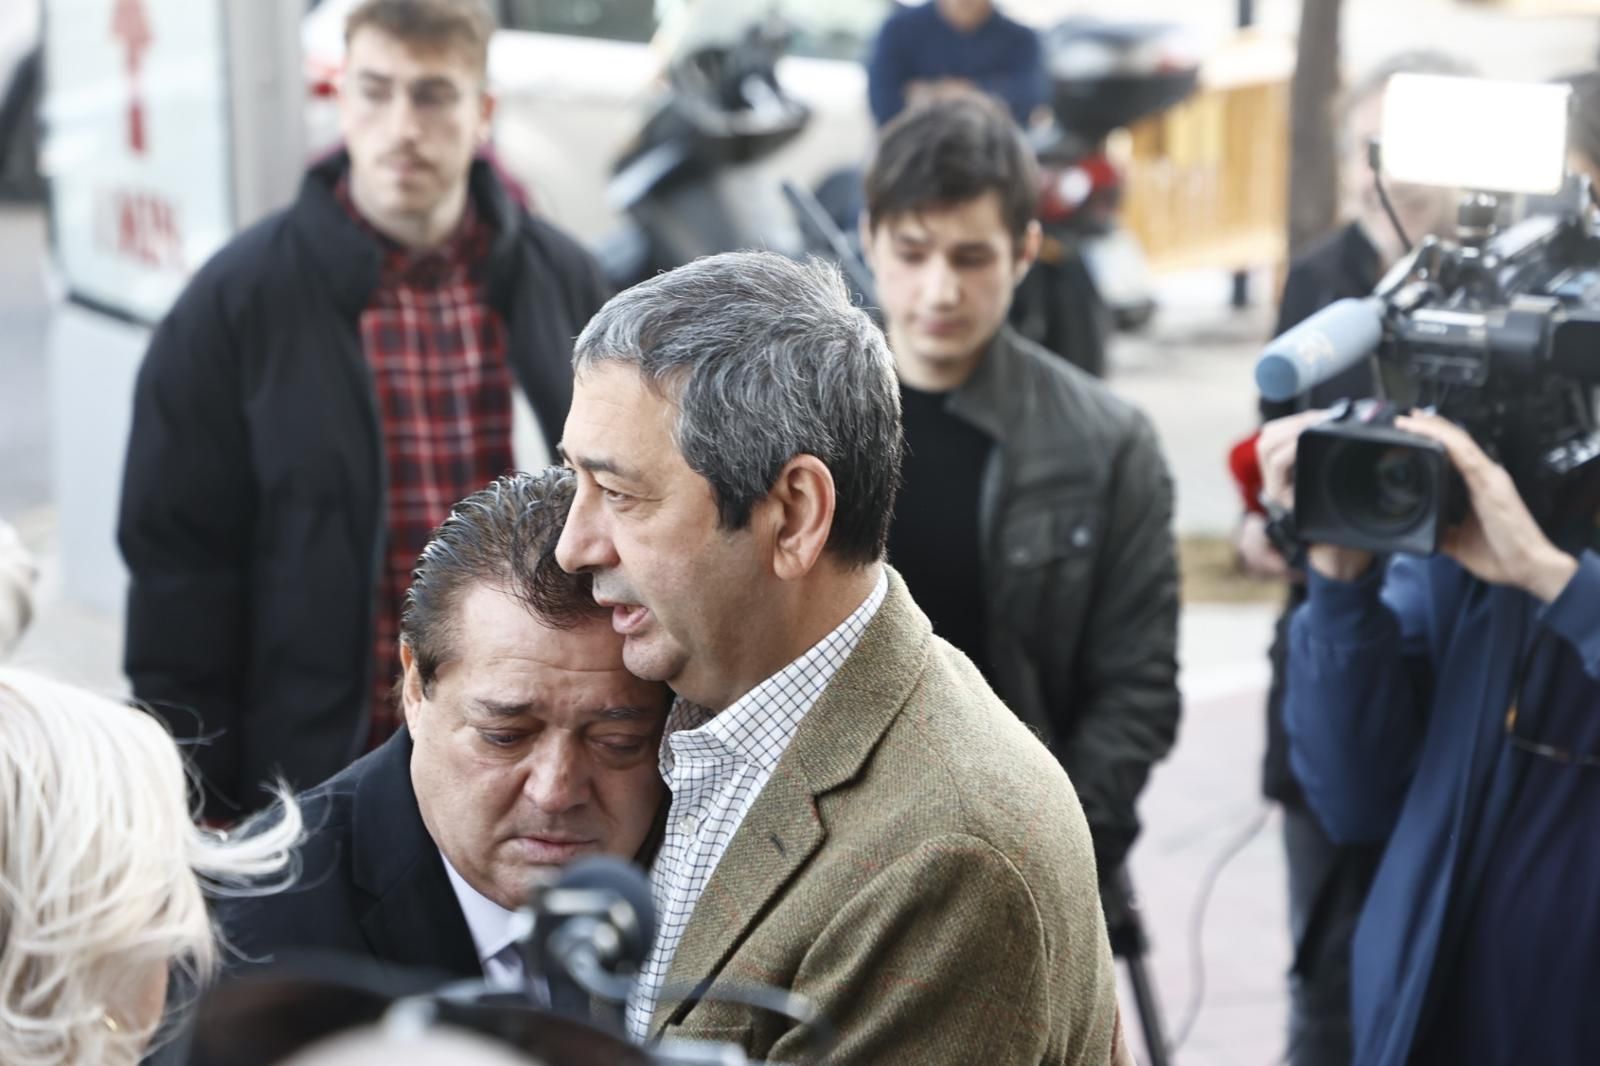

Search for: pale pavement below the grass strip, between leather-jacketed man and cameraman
xmin=1123 ymin=605 xmax=1290 ymax=1066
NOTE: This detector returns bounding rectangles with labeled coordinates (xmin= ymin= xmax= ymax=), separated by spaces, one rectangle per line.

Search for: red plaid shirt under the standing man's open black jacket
xmin=339 ymin=182 xmax=514 ymax=747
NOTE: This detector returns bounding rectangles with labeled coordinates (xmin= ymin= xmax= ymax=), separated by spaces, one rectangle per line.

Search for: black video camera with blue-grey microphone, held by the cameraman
xmin=1258 ymin=192 xmax=1600 ymax=555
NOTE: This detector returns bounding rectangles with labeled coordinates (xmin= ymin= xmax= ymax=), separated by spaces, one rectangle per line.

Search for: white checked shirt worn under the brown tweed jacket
xmin=627 ymin=570 xmax=890 ymax=1040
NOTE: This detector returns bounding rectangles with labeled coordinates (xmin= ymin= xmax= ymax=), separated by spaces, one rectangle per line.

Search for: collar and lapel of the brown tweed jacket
xmin=650 ymin=567 xmax=933 ymax=1036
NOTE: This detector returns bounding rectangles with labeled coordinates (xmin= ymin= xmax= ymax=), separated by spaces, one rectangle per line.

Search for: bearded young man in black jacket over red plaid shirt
xmin=118 ymin=0 xmax=605 ymax=821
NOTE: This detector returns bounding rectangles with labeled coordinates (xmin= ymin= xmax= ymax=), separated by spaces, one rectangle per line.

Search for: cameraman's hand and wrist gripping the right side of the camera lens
xmin=1395 ymin=411 xmax=1578 ymax=603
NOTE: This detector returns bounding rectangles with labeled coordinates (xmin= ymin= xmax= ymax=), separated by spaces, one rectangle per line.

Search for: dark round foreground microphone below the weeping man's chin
xmin=523 ymin=855 xmax=656 ymax=1023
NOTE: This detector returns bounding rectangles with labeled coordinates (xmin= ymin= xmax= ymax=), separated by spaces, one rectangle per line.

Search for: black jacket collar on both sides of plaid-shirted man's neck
xmin=290 ymin=149 xmax=522 ymax=315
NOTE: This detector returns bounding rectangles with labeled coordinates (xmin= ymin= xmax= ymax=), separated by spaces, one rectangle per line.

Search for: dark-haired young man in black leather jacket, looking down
xmin=861 ymin=94 xmax=1179 ymax=880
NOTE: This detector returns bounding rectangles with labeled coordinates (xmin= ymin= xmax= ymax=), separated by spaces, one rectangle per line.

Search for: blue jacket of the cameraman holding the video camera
xmin=1285 ymin=552 xmax=1600 ymax=1066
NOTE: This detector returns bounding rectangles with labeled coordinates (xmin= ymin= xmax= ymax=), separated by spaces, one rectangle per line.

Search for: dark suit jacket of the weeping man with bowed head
xmin=218 ymin=730 xmax=483 ymax=978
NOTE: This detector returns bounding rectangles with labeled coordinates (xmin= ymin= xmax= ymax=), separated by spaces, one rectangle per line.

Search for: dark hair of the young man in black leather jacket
xmin=866 ymin=91 xmax=1038 ymax=243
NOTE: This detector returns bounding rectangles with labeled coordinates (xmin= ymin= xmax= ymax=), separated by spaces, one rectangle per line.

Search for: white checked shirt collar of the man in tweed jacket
xmin=661 ymin=567 xmax=890 ymax=786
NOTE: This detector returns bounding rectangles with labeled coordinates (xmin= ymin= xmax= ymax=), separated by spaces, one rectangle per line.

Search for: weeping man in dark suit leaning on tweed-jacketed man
xmin=221 ymin=467 xmax=669 ymax=984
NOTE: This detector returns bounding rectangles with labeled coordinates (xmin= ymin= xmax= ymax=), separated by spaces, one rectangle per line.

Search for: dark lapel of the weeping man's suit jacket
xmin=350 ymin=728 xmax=483 ymax=976
